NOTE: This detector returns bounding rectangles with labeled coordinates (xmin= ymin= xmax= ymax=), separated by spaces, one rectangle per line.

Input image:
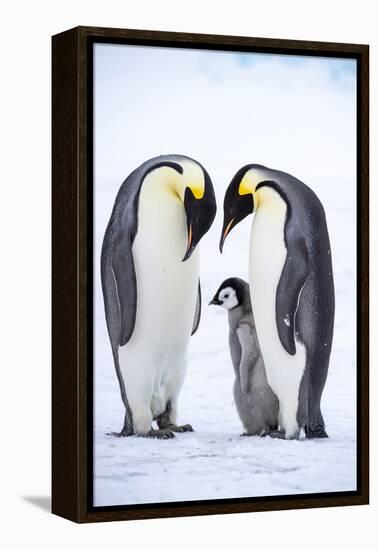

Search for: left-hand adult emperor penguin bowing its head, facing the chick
xmin=101 ymin=155 xmax=216 ymax=439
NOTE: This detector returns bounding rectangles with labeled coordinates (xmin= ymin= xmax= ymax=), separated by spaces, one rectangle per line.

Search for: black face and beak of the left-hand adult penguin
xmin=182 ymin=178 xmax=217 ymax=262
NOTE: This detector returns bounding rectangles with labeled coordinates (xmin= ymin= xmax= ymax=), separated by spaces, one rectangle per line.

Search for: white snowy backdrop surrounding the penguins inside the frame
xmin=94 ymin=45 xmax=356 ymax=506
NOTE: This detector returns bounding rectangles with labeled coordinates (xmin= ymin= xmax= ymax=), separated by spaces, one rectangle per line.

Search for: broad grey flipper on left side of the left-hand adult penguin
xmin=112 ymin=232 xmax=137 ymax=346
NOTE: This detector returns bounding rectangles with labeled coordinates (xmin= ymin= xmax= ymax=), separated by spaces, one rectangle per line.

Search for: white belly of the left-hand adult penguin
xmin=119 ymin=184 xmax=199 ymax=433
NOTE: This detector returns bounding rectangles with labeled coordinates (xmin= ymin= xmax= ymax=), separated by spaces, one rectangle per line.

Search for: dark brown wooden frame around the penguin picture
xmin=52 ymin=27 xmax=369 ymax=523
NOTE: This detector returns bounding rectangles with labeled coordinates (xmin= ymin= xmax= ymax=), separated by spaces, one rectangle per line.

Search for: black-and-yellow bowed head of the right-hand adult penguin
xmin=219 ymin=164 xmax=266 ymax=253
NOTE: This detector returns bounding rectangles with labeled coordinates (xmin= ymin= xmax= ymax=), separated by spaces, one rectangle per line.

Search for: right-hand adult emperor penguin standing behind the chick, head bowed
xmin=220 ymin=164 xmax=335 ymax=439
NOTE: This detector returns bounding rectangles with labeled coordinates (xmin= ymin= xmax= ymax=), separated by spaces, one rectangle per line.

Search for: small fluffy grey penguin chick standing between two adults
xmin=209 ymin=277 xmax=278 ymax=436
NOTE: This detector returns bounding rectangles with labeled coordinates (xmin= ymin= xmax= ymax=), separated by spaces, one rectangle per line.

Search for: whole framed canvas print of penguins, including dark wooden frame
xmin=52 ymin=27 xmax=369 ymax=522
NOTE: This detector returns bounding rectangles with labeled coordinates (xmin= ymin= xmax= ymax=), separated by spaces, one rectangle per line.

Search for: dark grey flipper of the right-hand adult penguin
xmin=276 ymin=237 xmax=309 ymax=355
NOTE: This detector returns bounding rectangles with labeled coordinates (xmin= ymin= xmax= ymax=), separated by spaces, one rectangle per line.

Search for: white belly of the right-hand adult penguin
xmin=249 ymin=194 xmax=306 ymax=438
